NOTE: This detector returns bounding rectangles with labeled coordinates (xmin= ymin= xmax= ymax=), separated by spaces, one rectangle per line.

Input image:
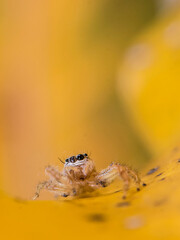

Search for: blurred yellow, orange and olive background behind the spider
xmin=0 ymin=0 xmax=180 ymax=202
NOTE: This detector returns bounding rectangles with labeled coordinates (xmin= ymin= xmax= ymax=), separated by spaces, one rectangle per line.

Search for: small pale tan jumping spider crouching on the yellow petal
xmin=33 ymin=153 xmax=146 ymax=199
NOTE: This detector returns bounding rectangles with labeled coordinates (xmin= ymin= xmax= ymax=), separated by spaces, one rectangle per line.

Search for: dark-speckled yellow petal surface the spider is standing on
xmin=0 ymin=143 xmax=180 ymax=240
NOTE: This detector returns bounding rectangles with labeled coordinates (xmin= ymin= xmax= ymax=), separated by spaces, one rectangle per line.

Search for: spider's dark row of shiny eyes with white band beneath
xmin=65 ymin=153 xmax=89 ymax=167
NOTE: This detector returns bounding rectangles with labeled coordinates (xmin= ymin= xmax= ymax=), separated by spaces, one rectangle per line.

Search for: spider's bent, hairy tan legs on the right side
xmin=96 ymin=163 xmax=145 ymax=199
